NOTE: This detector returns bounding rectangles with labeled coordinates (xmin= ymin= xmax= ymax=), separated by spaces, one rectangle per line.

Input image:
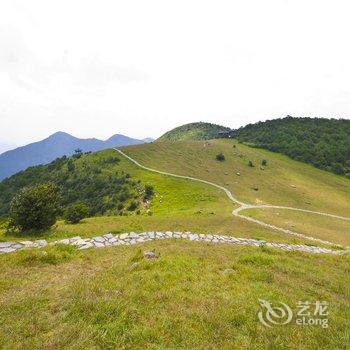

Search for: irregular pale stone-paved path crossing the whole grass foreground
xmin=0 ymin=231 xmax=350 ymax=255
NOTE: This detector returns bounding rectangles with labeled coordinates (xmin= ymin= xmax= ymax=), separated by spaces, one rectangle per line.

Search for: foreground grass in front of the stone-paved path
xmin=0 ymin=241 xmax=350 ymax=350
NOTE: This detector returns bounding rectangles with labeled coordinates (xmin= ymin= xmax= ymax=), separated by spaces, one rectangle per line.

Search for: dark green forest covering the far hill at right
xmin=236 ymin=117 xmax=350 ymax=178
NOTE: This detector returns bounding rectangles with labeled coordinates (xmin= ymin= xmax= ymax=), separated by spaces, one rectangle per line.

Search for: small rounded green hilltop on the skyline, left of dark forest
xmin=157 ymin=122 xmax=230 ymax=141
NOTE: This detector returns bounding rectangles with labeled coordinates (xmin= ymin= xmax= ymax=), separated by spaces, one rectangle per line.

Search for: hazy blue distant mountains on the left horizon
xmin=0 ymin=131 xmax=152 ymax=181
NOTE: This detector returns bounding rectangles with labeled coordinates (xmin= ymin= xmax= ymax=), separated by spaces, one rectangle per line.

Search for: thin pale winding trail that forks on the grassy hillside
xmin=114 ymin=148 xmax=350 ymax=247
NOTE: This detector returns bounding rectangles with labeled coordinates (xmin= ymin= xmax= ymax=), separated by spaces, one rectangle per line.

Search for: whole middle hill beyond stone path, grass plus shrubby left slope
xmin=0 ymin=139 xmax=350 ymax=245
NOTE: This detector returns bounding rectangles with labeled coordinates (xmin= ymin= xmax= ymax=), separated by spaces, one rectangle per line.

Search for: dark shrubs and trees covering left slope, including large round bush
xmin=0 ymin=152 xmax=154 ymax=231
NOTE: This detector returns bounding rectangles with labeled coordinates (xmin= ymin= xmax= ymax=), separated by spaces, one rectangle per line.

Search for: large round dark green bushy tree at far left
xmin=10 ymin=183 xmax=61 ymax=231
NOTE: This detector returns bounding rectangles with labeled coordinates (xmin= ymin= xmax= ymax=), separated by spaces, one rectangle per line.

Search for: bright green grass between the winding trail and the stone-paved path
xmin=0 ymin=145 xmax=318 ymax=243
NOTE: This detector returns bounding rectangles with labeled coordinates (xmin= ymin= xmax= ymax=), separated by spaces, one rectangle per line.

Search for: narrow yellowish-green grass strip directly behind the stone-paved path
xmin=0 ymin=214 xmax=318 ymax=248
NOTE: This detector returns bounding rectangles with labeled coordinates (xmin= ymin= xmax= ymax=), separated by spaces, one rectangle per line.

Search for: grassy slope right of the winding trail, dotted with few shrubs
xmin=124 ymin=140 xmax=350 ymax=244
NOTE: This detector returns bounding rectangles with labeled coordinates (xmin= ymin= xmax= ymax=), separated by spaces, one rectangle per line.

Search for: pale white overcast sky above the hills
xmin=0 ymin=0 xmax=350 ymax=150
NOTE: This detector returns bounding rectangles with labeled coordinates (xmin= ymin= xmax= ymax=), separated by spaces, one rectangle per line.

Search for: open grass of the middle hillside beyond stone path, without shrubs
xmin=0 ymin=140 xmax=350 ymax=244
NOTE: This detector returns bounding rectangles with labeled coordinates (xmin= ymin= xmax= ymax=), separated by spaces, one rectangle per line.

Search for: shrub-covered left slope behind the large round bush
xmin=0 ymin=154 xmax=149 ymax=216
